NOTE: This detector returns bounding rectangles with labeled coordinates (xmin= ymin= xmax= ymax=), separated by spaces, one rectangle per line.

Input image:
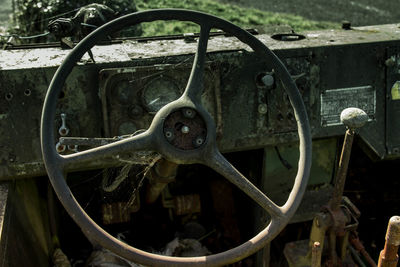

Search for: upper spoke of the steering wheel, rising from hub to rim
xmin=184 ymin=23 xmax=211 ymax=103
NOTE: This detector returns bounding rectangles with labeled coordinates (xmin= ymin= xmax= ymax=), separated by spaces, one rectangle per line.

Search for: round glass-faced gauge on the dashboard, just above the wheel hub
xmin=143 ymin=78 xmax=180 ymax=113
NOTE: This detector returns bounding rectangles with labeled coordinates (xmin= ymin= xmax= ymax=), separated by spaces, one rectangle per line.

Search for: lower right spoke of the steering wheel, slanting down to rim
xmin=206 ymin=150 xmax=283 ymax=217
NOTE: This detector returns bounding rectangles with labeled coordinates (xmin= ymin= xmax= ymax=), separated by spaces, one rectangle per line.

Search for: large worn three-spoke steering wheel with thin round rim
xmin=41 ymin=9 xmax=311 ymax=266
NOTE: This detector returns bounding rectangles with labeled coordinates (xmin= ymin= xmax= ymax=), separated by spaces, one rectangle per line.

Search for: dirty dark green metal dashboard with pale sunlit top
xmin=0 ymin=25 xmax=400 ymax=180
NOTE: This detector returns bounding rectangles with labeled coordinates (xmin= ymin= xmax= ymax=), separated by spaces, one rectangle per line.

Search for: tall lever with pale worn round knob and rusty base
xmin=285 ymin=108 xmax=368 ymax=266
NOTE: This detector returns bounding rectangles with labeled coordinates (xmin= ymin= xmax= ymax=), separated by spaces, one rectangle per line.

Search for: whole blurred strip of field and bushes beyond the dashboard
xmin=0 ymin=0 xmax=400 ymax=39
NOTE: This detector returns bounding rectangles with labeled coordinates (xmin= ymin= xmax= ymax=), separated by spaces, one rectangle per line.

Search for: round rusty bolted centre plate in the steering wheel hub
xmin=164 ymin=108 xmax=207 ymax=150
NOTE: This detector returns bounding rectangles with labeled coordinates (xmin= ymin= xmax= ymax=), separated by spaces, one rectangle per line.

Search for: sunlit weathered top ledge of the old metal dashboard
xmin=0 ymin=24 xmax=400 ymax=69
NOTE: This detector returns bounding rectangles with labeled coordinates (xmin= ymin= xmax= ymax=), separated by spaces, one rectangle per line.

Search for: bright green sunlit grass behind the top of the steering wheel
xmin=136 ymin=0 xmax=338 ymax=36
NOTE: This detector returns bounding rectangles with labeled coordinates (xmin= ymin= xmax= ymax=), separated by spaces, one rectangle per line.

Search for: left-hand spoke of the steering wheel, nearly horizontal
xmin=60 ymin=131 xmax=155 ymax=170
